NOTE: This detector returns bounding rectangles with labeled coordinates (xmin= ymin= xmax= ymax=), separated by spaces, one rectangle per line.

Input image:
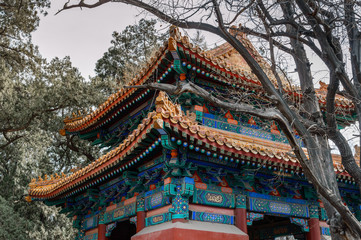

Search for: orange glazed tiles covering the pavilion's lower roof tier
xmin=29 ymin=92 xmax=352 ymax=198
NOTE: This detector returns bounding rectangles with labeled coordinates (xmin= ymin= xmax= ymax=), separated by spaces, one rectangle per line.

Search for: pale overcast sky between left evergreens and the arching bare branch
xmin=33 ymin=0 xmax=152 ymax=78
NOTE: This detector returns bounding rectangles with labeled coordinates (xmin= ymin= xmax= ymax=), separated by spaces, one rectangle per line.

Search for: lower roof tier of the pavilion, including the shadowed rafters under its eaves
xmin=29 ymin=92 xmax=351 ymax=200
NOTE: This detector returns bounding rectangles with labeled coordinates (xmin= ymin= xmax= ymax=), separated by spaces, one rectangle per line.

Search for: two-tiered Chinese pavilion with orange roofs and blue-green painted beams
xmin=27 ymin=27 xmax=360 ymax=240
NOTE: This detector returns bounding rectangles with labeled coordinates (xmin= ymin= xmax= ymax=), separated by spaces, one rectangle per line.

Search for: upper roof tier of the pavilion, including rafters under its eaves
xmin=65 ymin=28 xmax=354 ymax=135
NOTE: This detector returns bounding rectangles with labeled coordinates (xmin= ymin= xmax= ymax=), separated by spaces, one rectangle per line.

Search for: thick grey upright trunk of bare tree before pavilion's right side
xmin=281 ymin=1 xmax=359 ymax=236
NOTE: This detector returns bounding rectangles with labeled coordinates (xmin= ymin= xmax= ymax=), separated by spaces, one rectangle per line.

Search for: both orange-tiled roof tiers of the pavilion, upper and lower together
xmin=28 ymin=28 xmax=354 ymax=200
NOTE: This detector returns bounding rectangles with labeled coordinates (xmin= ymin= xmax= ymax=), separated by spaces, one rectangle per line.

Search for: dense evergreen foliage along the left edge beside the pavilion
xmin=0 ymin=0 xmax=111 ymax=240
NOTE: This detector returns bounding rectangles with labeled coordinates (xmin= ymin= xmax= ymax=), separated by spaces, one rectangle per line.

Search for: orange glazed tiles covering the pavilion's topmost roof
xmin=64 ymin=27 xmax=354 ymax=135
